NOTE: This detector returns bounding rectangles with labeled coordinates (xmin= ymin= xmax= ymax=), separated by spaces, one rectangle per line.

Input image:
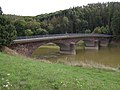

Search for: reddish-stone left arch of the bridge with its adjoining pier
xmin=9 ymin=41 xmax=75 ymax=57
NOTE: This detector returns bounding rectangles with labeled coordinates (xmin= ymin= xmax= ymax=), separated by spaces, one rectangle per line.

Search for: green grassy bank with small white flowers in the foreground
xmin=0 ymin=53 xmax=120 ymax=90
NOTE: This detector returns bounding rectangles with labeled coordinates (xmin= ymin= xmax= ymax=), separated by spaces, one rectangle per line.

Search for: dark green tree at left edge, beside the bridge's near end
xmin=0 ymin=8 xmax=16 ymax=48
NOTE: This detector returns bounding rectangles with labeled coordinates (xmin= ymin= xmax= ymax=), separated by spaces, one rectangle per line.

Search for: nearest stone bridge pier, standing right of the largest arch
xmin=60 ymin=42 xmax=76 ymax=55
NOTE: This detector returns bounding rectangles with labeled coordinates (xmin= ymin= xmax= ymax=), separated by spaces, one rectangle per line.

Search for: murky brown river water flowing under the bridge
xmin=33 ymin=45 xmax=120 ymax=67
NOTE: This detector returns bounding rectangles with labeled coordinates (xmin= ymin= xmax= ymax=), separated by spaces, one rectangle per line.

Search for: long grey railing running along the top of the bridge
xmin=16 ymin=33 xmax=112 ymax=40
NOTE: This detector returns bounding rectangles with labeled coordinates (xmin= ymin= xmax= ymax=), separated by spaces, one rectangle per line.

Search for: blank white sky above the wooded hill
xmin=0 ymin=0 xmax=120 ymax=16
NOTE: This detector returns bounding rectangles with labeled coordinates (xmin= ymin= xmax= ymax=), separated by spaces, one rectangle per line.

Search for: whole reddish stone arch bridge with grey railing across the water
xmin=9 ymin=34 xmax=112 ymax=56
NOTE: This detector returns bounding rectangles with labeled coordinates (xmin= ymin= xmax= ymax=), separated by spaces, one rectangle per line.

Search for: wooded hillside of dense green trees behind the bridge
xmin=0 ymin=2 xmax=120 ymax=38
